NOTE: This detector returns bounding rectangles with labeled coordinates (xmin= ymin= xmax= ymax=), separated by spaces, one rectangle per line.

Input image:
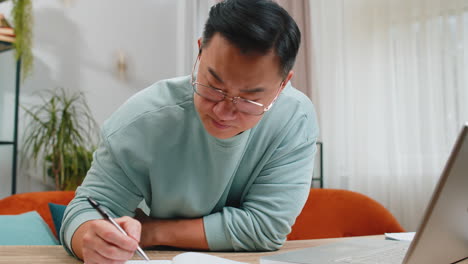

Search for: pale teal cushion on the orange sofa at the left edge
xmin=0 ymin=211 xmax=58 ymax=245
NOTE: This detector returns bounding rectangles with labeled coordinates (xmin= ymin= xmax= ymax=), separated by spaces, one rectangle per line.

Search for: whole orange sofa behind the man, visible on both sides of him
xmin=0 ymin=189 xmax=404 ymax=240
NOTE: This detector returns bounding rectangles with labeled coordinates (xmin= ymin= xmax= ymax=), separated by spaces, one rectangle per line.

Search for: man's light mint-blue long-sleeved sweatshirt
xmin=60 ymin=77 xmax=318 ymax=255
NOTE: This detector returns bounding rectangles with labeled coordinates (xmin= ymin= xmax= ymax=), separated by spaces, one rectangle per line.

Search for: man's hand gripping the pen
xmin=72 ymin=216 xmax=141 ymax=264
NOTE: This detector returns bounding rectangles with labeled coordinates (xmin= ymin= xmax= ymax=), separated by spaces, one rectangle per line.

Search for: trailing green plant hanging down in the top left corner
xmin=0 ymin=0 xmax=33 ymax=80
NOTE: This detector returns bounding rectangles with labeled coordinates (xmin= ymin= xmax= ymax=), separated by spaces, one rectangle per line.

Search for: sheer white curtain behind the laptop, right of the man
xmin=292 ymin=0 xmax=468 ymax=230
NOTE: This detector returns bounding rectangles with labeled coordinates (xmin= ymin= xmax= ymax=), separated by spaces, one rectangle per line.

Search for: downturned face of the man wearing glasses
xmin=194 ymin=33 xmax=292 ymax=139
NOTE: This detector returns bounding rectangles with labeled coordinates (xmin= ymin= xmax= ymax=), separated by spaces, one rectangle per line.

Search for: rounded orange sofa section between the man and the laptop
xmin=288 ymin=189 xmax=405 ymax=240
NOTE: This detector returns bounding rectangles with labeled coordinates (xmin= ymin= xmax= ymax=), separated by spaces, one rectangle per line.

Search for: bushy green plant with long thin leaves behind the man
xmin=22 ymin=89 xmax=97 ymax=190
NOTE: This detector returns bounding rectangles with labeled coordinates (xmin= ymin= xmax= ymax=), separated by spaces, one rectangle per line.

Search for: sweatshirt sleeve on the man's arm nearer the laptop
xmin=204 ymin=112 xmax=318 ymax=251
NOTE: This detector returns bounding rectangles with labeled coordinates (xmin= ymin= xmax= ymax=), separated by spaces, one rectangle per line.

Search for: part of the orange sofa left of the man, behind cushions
xmin=0 ymin=191 xmax=75 ymax=235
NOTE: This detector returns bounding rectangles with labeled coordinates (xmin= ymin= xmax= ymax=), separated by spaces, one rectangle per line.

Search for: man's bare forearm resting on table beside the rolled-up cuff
xmin=141 ymin=218 xmax=209 ymax=250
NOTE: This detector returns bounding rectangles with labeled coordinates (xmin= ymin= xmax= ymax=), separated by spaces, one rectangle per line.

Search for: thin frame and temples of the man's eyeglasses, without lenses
xmin=190 ymin=56 xmax=284 ymax=116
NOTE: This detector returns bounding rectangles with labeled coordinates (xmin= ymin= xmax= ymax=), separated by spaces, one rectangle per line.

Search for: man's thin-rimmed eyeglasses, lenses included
xmin=191 ymin=57 xmax=284 ymax=115
